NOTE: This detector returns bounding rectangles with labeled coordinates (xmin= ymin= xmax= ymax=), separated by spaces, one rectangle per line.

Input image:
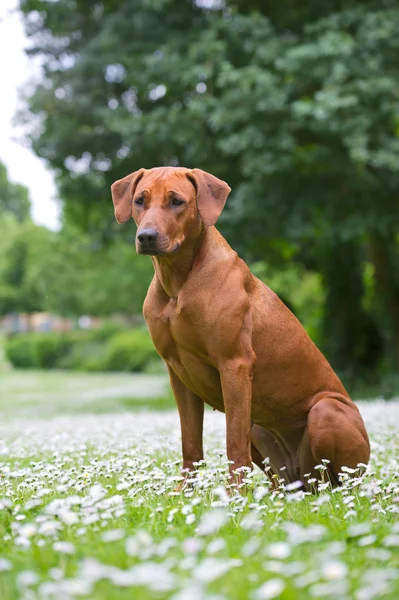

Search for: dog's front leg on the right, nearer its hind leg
xmin=220 ymin=359 xmax=253 ymax=485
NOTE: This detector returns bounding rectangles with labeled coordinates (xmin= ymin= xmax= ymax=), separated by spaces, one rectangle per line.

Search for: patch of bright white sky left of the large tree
xmin=0 ymin=0 xmax=60 ymax=229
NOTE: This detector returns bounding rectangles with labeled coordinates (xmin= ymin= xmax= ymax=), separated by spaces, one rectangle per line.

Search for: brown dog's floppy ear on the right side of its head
xmin=187 ymin=169 xmax=231 ymax=226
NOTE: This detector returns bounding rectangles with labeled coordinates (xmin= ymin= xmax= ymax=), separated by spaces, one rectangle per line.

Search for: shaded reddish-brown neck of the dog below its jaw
xmin=152 ymin=226 xmax=214 ymax=298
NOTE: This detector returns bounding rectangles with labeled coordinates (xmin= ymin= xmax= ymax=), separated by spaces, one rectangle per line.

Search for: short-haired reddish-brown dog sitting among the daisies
xmin=112 ymin=167 xmax=370 ymax=484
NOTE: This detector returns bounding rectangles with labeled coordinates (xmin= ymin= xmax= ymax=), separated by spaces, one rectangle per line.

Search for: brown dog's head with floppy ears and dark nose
xmin=111 ymin=167 xmax=230 ymax=256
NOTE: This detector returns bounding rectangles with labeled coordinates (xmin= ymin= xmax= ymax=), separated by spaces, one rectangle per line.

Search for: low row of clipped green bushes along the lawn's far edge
xmin=5 ymin=325 xmax=159 ymax=372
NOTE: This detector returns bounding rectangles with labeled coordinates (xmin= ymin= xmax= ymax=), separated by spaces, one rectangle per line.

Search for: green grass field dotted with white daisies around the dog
xmin=0 ymin=372 xmax=399 ymax=600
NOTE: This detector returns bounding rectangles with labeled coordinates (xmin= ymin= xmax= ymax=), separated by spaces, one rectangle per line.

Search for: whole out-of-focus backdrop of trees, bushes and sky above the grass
xmin=0 ymin=0 xmax=399 ymax=404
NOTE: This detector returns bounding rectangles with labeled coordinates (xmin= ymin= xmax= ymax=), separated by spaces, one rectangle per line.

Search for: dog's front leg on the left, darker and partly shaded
xmin=168 ymin=367 xmax=204 ymax=484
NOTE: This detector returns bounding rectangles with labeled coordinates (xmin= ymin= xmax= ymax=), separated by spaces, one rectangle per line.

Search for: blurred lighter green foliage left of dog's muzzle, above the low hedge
xmin=0 ymin=215 xmax=152 ymax=316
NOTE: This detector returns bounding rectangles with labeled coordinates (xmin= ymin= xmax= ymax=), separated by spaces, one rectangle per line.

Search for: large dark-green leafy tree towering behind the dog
xmin=21 ymin=0 xmax=399 ymax=369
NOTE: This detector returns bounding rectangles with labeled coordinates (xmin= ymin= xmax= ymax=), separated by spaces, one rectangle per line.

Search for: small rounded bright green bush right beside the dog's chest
xmin=105 ymin=329 xmax=159 ymax=371
